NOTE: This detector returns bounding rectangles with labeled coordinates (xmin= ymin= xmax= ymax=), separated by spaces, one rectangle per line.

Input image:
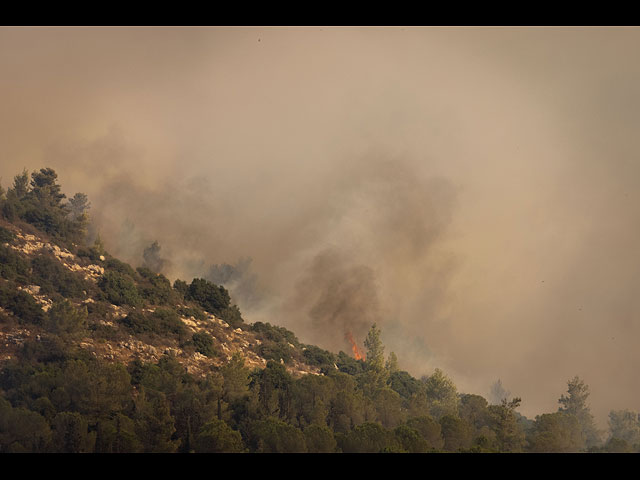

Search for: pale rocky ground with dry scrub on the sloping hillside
xmin=0 ymin=218 xmax=320 ymax=377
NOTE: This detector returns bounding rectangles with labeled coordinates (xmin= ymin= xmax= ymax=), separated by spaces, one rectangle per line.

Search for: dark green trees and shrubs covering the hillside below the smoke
xmin=0 ymin=168 xmax=640 ymax=453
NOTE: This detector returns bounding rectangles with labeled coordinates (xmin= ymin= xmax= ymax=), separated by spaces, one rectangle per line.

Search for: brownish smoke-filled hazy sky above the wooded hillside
xmin=0 ymin=27 xmax=640 ymax=426
